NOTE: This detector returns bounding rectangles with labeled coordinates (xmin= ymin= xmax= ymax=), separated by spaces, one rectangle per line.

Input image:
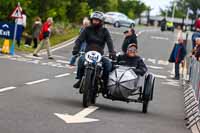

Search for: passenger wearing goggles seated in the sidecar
xmin=117 ymin=43 xmax=147 ymax=76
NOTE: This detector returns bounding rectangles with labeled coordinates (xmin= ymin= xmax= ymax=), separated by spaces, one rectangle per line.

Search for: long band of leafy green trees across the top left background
xmin=0 ymin=0 xmax=148 ymax=28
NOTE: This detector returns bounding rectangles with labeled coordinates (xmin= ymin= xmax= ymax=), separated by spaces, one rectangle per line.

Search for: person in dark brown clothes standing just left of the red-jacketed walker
xmin=32 ymin=17 xmax=42 ymax=48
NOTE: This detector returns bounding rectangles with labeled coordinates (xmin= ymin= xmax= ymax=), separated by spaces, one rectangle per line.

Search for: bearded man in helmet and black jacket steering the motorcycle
xmin=72 ymin=11 xmax=116 ymax=88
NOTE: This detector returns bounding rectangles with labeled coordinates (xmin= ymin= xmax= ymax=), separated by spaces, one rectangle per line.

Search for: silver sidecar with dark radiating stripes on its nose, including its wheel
xmin=106 ymin=66 xmax=155 ymax=113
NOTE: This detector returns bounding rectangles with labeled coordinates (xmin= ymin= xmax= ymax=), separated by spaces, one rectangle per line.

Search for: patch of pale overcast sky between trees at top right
xmin=141 ymin=0 xmax=173 ymax=15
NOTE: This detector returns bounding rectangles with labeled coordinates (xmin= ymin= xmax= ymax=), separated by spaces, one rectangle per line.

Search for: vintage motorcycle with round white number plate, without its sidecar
xmin=80 ymin=51 xmax=104 ymax=107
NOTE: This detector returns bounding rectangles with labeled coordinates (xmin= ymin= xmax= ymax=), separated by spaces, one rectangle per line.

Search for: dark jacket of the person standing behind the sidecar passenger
xmin=122 ymin=33 xmax=137 ymax=53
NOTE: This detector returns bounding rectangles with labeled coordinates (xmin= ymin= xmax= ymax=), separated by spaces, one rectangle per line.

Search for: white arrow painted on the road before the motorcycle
xmin=54 ymin=106 xmax=99 ymax=124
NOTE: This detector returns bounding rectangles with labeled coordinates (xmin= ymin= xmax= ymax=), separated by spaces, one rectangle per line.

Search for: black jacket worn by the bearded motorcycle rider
xmin=72 ymin=25 xmax=114 ymax=55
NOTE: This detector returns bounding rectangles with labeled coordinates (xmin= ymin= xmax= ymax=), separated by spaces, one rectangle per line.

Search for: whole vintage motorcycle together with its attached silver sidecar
xmin=79 ymin=51 xmax=155 ymax=113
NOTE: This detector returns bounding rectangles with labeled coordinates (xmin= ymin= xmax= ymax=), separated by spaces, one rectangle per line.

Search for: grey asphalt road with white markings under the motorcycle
xmin=0 ymin=28 xmax=189 ymax=133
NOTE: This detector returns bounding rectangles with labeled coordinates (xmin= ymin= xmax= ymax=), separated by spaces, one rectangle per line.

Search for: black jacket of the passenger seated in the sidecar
xmin=117 ymin=55 xmax=147 ymax=76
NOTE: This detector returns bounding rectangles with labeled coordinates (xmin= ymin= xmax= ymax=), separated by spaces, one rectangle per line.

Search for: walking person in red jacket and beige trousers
xmin=33 ymin=17 xmax=53 ymax=59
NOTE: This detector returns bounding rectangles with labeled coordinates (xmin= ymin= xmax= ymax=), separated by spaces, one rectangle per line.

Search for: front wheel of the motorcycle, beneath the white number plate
xmin=83 ymin=70 xmax=92 ymax=107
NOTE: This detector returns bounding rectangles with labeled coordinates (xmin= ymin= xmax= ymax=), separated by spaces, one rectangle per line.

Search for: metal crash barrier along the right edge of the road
xmin=183 ymin=57 xmax=200 ymax=133
